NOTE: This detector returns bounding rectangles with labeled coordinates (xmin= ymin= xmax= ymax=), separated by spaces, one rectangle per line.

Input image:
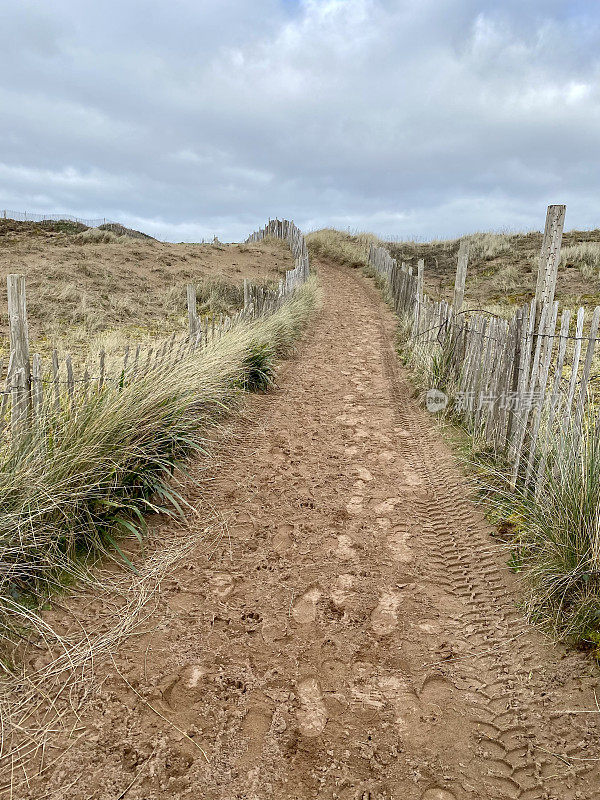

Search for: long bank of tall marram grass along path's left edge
xmin=0 ymin=281 xmax=316 ymax=635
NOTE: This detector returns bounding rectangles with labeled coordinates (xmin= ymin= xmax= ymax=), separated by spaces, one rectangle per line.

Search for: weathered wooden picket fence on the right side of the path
xmin=368 ymin=206 xmax=600 ymax=493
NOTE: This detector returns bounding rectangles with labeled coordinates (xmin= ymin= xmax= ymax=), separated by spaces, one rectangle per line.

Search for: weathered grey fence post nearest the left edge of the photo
xmin=6 ymin=274 xmax=31 ymax=433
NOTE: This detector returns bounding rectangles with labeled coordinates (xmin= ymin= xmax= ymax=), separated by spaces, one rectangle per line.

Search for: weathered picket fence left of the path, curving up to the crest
xmin=0 ymin=220 xmax=309 ymax=446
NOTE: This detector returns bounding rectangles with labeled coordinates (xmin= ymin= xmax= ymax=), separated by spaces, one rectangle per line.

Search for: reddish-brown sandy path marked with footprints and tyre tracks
xmin=31 ymin=265 xmax=600 ymax=800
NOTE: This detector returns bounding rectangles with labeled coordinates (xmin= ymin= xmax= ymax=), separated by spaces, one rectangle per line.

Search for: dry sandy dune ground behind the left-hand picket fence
xmin=0 ymin=225 xmax=293 ymax=351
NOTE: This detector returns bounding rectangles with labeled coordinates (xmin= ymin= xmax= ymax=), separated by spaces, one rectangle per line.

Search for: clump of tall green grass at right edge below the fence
xmin=483 ymin=419 xmax=600 ymax=649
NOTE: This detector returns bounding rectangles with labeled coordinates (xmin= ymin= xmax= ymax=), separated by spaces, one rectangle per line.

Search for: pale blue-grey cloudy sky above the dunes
xmin=0 ymin=0 xmax=600 ymax=241
